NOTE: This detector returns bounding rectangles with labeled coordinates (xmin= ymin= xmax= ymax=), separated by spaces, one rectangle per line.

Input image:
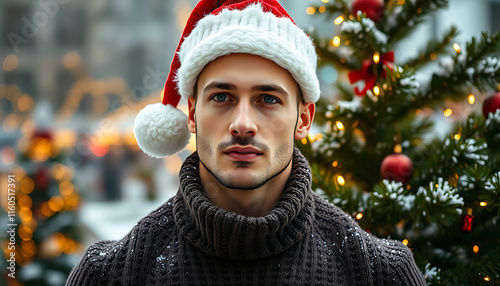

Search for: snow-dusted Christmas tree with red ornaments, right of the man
xmin=297 ymin=0 xmax=500 ymax=285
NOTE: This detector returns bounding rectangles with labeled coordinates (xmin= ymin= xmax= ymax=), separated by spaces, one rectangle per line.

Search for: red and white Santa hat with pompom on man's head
xmin=134 ymin=0 xmax=320 ymax=158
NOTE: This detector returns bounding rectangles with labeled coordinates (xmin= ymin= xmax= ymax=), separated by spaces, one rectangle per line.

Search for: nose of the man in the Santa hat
xmin=229 ymin=102 xmax=257 ymax=136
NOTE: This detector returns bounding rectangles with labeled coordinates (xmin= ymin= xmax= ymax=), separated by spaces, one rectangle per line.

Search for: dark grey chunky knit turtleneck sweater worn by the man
xmin=67 ymin=149 xmax=425 ymax=286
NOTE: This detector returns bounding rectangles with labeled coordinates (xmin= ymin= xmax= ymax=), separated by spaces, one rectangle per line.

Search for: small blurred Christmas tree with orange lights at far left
xmin=0 ymin=129 xmax=84 ymax=286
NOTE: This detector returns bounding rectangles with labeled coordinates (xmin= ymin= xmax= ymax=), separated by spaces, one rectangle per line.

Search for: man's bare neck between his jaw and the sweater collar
xmin=199 ymin=164 xmax=292 ymax=217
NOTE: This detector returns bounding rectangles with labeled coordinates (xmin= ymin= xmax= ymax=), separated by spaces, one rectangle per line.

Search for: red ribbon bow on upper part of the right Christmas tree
xmin=349 ymin=51 xmax=394 ymax=96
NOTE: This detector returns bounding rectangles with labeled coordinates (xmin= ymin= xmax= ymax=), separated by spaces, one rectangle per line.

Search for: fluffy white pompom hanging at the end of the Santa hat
xmin=134 ymin=103 xmax=191 ymax=158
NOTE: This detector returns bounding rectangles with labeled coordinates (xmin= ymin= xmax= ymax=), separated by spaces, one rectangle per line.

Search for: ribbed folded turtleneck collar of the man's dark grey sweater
xmin=174 ymin=148 xmax=314 ymax=259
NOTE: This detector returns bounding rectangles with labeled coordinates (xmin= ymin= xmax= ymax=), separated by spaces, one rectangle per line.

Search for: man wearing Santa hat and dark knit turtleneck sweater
xmin=67 ymin=0 xmax=425 ymax=285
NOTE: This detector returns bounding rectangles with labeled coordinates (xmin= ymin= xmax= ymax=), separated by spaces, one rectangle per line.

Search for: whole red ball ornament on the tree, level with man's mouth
xmin=380 ymin=153 xmax=413 ymax=184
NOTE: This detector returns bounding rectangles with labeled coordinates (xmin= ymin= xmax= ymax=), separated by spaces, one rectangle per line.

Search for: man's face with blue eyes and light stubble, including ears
xmin=189 ymin=54 xmax=314 ymax=189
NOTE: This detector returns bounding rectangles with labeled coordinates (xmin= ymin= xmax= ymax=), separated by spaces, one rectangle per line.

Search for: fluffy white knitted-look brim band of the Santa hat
xmin=177 ymin=4 xmax=320 ymax=102
